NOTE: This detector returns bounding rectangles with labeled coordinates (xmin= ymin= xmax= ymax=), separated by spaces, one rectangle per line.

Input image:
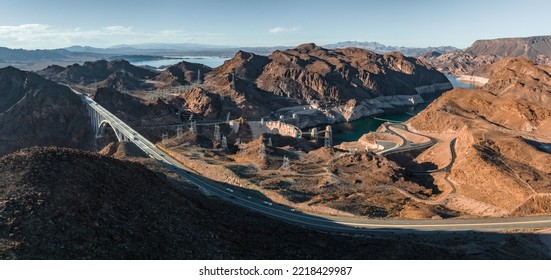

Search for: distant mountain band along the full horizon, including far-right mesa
xmin=0 ymin=36 xmax=551 ymax=73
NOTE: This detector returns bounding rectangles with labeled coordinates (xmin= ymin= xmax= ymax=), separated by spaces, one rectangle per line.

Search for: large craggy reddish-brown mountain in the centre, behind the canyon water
xmin=204 ymin=44 xmax=451 ymax=120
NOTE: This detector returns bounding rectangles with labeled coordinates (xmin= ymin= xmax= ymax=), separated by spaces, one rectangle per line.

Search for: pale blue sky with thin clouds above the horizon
xmin=0 ymin=0 xmax=551 ymax=49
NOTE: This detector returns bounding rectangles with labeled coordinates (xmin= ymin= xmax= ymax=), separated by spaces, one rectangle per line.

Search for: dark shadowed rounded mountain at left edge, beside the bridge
xmin=0 ymin=67 xmax=92 ymax=155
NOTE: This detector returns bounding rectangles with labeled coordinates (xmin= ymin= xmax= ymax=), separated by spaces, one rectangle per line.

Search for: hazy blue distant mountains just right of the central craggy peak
xmin=323 ymin=41 xmax=457 ymax=57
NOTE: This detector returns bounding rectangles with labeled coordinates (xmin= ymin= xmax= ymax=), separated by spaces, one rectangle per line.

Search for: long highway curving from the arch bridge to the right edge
xmin=73 ymin=87 xmax=551 ymax=234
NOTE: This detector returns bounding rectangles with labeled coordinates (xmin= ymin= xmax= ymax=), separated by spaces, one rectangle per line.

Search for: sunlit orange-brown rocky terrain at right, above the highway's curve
xmin=155 ymin=58 xmax=551 ymax=219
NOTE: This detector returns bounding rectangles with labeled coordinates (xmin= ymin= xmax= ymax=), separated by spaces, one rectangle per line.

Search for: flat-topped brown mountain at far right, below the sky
xmin=421 ymin=36 xmax=551 ymax=76
